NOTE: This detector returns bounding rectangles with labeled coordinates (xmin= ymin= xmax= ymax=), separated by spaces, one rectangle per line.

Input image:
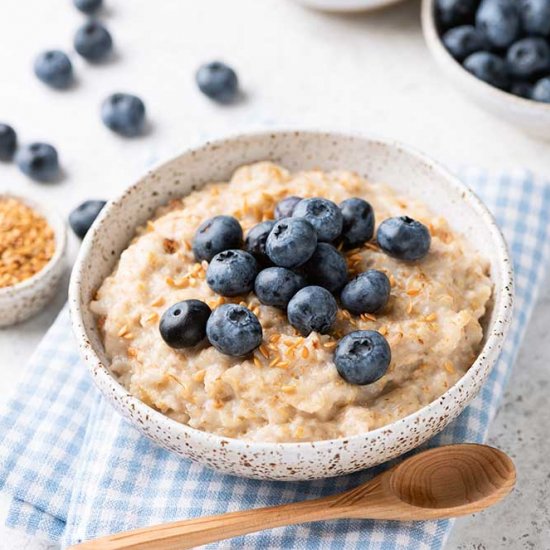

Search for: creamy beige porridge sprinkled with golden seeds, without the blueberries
xmin=91 ymin=162 xmax=492 ymax=441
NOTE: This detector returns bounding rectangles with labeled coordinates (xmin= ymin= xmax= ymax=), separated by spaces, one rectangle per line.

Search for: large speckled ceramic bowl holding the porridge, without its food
xmin=69 ymin=132 xmax=512 ymax=480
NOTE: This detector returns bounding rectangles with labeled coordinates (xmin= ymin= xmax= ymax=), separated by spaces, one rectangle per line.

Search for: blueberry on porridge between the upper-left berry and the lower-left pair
xmin=206 ymin=250 xmax=258 ymax=296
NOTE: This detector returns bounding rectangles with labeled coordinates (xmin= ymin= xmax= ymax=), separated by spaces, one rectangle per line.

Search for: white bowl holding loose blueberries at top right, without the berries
xmin=422 ymin=0 xmax=550 ymax=140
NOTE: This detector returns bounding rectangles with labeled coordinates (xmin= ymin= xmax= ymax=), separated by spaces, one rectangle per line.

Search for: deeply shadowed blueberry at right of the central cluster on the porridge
xmin=303 ymin=243 xmax=348 ymax=294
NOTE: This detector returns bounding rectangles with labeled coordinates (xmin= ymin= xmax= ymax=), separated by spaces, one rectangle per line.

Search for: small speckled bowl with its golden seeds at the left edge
xmin=0 ymin=193 xmax=66 ymax=327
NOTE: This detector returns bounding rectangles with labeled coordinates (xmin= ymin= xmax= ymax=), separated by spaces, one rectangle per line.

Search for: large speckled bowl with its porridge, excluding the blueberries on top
xmin=69 ymin=132 xmax=512 ymax=479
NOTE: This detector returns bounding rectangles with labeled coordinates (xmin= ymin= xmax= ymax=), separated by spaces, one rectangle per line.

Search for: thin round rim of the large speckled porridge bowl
xmin=69 ymin=128 xmax=514 ymax=452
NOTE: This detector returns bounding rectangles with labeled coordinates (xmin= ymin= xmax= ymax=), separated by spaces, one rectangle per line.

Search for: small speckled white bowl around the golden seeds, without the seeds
xmin=0 ymin=193 xmax=67 ymax=327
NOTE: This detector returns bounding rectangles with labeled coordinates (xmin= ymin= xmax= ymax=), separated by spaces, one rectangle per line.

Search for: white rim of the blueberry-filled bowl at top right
xmin=420 ymin=0 xmax=550 ymax=115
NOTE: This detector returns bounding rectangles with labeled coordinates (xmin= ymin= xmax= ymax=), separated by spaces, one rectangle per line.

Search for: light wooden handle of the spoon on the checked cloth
xmin=71 ymin=496 xmax=344 ymax=550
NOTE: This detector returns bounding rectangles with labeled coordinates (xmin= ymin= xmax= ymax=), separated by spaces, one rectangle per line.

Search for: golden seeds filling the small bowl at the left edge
xmin=0 ymin=197 xmax=55 ymax=288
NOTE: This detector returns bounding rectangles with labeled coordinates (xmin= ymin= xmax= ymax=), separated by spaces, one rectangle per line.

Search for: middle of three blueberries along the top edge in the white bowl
xmin=476 ymin=0 xmax=521 ymax=48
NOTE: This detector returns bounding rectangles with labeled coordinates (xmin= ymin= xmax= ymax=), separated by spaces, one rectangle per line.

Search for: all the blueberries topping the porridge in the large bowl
xmin=159 ymin=196 xmax=431 ymax=385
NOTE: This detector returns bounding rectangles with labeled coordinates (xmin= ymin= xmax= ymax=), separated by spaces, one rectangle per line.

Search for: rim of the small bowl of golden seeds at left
xmin=0 ymin=191 xmax=67 ymax=299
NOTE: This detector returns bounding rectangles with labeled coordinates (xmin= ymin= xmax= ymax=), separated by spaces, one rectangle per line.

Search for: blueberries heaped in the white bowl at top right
xmin=435 ymin=0 xmax=550 ymax=103
